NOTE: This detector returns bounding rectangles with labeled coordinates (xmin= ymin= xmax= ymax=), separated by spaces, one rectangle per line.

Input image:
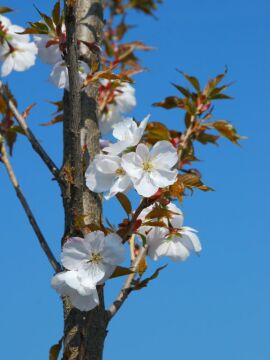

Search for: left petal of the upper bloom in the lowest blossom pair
xmin=61 ymin=237 xmax=89 ymax=270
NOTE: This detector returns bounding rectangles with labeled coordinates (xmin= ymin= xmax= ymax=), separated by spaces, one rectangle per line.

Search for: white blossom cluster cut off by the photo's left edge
xmin=0 ymin=15 xmax=38 ymax=76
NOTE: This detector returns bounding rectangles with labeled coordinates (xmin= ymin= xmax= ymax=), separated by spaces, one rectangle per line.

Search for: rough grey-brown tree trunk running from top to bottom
xmin=61 ymin=0 xmax=108 ymax=360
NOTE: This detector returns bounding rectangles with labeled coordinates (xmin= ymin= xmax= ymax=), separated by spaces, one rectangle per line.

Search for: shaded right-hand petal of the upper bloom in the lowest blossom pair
xmin=102 ymin=234 xmax=125 ymax=265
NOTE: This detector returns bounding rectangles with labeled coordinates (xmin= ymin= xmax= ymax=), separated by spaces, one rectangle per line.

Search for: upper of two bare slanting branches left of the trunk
xmin=0 ymin=81 xmax=59 ymax=180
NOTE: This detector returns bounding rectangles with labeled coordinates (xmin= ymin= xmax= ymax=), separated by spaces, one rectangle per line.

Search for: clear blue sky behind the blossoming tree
xmin=0 ymin=0 xmax=270 ymax=360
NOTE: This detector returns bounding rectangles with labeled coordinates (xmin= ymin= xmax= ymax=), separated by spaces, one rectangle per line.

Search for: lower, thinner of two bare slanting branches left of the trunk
xmin=0 ymin=137 xmax=61 ymax=272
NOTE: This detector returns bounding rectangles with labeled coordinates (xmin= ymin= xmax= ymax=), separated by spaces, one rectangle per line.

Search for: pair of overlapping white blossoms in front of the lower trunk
xmin=52 ymin=231 xmax=125 ymax=311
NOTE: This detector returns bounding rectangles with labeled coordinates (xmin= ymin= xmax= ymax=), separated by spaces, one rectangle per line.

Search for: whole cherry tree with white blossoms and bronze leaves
xmin=0 ymin=0 xmax=242 ymax=360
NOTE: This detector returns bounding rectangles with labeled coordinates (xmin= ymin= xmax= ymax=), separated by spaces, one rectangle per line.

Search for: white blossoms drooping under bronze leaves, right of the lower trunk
xmin=139 ymin=203 xmax=202 ymax=261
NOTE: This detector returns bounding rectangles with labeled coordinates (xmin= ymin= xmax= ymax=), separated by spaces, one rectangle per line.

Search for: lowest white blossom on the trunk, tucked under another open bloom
xmin=51 ymin=271 xmax=99 ymax=311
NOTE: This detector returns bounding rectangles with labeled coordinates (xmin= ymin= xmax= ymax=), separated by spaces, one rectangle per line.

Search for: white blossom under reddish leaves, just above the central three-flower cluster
xmin=99 ymin=79 xmax=136 ymax=135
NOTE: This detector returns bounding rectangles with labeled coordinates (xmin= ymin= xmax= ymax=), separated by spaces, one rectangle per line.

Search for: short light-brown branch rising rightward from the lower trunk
xmin=108 ymin=245 xmax=148 ymax=320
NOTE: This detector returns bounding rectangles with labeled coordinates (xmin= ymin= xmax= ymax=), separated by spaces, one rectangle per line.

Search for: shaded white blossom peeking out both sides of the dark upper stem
xmin=49 ymin=60 xmax=90 ymax=90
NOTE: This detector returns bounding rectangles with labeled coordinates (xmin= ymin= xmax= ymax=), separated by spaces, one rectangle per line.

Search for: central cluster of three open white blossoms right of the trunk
xmin=86 ymin=117 xmax=178 ymax=199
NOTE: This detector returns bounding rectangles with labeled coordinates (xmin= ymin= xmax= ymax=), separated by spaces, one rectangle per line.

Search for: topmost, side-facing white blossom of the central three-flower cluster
xmin=103 ymin=115 xmax=150 ymax=155
